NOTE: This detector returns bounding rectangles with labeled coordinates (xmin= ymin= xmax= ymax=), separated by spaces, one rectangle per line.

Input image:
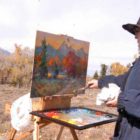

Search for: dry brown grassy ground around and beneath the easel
xmin=0 ymin=85 xmax=117 ymax=140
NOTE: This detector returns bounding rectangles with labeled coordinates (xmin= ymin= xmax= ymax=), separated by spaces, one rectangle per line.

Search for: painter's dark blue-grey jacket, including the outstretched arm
xmin=99 ymin=58 xmax=140 ymax=140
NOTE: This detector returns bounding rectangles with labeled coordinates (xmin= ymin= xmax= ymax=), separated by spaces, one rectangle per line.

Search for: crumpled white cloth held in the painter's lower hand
xmin=96 ymin=83 xmax=121 ymax=105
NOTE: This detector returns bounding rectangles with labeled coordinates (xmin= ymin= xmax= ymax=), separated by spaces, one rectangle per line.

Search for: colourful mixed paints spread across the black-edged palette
xmin=34 ymin=108 xmax=116 ymax=127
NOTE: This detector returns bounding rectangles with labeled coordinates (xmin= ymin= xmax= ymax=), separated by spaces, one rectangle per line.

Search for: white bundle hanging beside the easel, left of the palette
xmin=11 ymin=93 xmax=32 ymax=131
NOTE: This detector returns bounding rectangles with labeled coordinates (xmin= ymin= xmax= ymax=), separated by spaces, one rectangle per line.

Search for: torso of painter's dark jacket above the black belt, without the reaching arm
xmin=118 ymin=60 xmax=140 ymax=119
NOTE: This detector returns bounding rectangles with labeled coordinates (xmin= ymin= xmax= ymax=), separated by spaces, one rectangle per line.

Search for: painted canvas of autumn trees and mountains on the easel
xmin=31 ymin=31 xmax=89 ymax=97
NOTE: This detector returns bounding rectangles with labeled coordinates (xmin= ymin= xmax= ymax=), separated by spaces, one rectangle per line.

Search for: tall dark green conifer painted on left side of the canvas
xmin=39 ymin=39 xmax=48 ymax=78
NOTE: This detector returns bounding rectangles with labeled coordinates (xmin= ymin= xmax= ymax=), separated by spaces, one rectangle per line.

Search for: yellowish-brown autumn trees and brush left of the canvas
xmin=0 ymin=44 xmax=33 ymax=87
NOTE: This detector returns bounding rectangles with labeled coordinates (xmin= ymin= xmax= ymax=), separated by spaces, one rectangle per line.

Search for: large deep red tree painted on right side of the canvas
xmin=63 ymin=51 xmax=80 ymax=78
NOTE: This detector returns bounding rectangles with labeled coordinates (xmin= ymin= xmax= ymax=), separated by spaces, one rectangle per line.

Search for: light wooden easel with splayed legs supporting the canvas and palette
xmin=7 ymin=94 xmax=75 ymax=140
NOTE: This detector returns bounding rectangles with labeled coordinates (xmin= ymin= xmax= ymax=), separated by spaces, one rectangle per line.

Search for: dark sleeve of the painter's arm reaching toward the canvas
xmin=98 ymin=71 xmax=129 ymax=89
